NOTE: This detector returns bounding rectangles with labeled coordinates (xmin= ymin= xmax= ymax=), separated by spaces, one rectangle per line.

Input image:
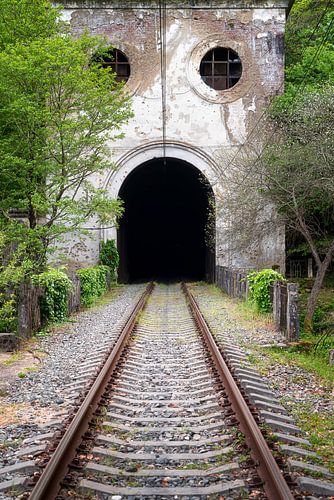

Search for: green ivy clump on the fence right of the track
xmin=247 ymin=269 xmax=285 ymax=312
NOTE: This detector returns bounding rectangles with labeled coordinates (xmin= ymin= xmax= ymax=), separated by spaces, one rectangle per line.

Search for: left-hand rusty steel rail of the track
xmin=29 ymin=283 xmax=154 ymax=500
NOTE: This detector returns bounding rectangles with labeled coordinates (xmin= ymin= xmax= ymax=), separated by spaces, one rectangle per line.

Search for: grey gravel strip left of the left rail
xmin=0 ymin=285 xmax=145 ymax=474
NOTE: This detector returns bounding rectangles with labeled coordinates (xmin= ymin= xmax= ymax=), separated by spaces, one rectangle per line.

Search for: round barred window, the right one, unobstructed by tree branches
xmin=200 ymin=47 xmax=242 ymax=90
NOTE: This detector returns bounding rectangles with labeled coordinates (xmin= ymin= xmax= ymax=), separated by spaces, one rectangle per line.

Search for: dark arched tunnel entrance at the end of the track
xmin=117 ymin=158 xmax=215 ymax=282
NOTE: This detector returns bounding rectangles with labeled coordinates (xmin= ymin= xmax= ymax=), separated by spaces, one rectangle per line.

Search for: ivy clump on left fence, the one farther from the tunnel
xmin=32 ymin=269 xmax=73 ymax=322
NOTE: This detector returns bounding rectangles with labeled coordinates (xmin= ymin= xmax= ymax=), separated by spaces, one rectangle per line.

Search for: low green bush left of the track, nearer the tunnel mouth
xmin=77 ymin=265 xmax=110 ymax=307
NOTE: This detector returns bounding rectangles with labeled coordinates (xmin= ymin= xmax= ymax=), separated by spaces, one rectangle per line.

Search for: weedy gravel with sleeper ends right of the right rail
xmin=191 ymin=284 xmax=334 ymax=498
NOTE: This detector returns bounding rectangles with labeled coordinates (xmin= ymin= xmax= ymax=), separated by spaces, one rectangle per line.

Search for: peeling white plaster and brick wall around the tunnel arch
xmin=58 ymin=0 xmax=287 ymax=274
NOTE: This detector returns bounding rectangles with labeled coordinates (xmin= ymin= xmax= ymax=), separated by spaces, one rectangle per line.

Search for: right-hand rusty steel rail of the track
xmin=182 ymin=283 xmax=294 ymax=500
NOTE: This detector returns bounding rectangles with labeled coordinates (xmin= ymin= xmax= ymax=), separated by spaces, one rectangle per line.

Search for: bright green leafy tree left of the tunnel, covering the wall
xmin=0 ymin=27 xmax=131 ymax=272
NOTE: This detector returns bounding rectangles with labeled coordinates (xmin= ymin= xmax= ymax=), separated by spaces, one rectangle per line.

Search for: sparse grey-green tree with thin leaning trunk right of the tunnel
xmin=222 ymin=86 xmax=334 ymax=331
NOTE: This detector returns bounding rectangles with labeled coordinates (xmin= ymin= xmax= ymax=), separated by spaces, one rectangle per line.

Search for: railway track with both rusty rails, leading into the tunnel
xmin=1 ymin=285 xmax=332 ymax=500
